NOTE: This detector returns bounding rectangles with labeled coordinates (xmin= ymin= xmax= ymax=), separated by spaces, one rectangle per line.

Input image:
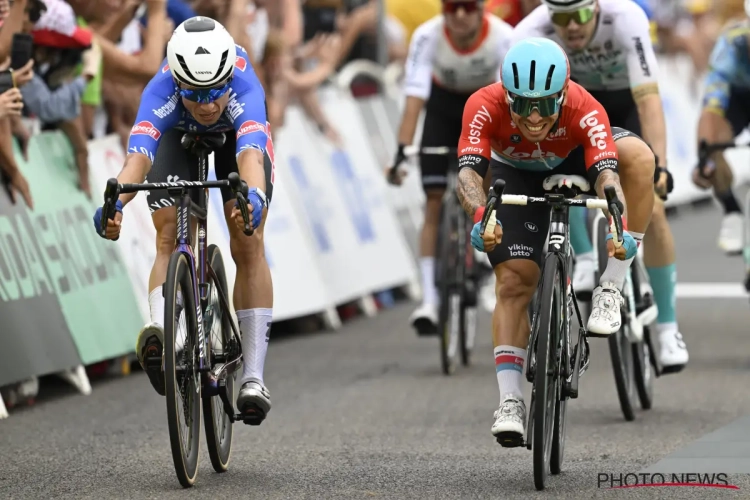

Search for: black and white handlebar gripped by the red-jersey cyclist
xmin=480 ymin=179 xmax=624 ymax=248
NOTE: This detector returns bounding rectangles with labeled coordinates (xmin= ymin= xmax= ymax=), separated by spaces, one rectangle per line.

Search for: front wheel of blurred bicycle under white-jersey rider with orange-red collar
xmin=438 ymin=196 xmax=463 ymax=375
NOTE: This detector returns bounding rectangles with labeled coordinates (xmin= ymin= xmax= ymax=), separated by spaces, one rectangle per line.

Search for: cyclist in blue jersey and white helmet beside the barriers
xmin=94 ymin=17 xmax=274 ymax=424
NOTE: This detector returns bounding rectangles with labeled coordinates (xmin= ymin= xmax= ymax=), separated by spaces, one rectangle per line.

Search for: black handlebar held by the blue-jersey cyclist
xmin=99 ymin=172 xmax=253 ymax=237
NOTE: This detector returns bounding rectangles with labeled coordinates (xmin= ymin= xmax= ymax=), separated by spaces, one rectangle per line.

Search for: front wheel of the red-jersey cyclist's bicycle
xmin=533 ymin=254 xmax=561 ymax=490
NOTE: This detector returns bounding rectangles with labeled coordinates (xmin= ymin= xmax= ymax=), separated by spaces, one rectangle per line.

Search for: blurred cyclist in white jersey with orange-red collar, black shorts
xmin=389 ymin=0 xmax=512 ymax=335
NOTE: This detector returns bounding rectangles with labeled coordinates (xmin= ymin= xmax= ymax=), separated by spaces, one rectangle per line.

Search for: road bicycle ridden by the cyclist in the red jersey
xmin=480 ymin=175 xmax=623 ymax=490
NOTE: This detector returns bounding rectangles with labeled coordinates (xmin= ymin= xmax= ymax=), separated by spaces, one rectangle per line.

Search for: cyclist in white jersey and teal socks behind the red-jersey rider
xmin=513 ymin=0 xmax=688 ymax=372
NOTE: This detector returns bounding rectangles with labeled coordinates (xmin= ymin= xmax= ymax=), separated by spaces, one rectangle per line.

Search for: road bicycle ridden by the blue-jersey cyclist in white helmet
xmin=101 ymin=134 xmax=259 ymax=488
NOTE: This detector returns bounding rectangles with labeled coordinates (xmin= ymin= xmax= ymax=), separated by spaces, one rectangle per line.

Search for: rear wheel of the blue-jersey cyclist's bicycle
xmin=203 ymin=245 xmax=236 ymax=472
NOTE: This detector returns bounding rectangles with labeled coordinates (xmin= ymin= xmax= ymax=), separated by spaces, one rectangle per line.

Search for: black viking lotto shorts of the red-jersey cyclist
xmin=488 ymin=127 xmax=640 ymax=268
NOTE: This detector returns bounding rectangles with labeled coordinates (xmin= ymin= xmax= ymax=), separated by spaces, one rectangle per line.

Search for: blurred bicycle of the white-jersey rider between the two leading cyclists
xmin=391 ymin=147 xmax=480 ymax=375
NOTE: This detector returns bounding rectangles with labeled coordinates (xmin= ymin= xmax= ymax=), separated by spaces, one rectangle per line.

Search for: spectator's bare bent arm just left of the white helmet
xmin=96 ymin=0 xmax=169 ymax=83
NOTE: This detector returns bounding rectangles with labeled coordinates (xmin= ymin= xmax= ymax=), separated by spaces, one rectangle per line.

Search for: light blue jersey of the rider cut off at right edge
xmin=703 ymin=20 xmax=750 ymax=111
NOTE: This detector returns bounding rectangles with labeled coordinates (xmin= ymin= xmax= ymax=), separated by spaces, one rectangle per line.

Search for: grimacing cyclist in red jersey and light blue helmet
xmin=457 ymin=38 xmax=655 ymax=446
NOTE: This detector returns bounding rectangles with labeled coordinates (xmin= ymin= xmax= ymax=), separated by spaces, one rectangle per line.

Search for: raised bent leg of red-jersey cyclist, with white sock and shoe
xmin=587 ymin=133 xmax=656 ymax=335
